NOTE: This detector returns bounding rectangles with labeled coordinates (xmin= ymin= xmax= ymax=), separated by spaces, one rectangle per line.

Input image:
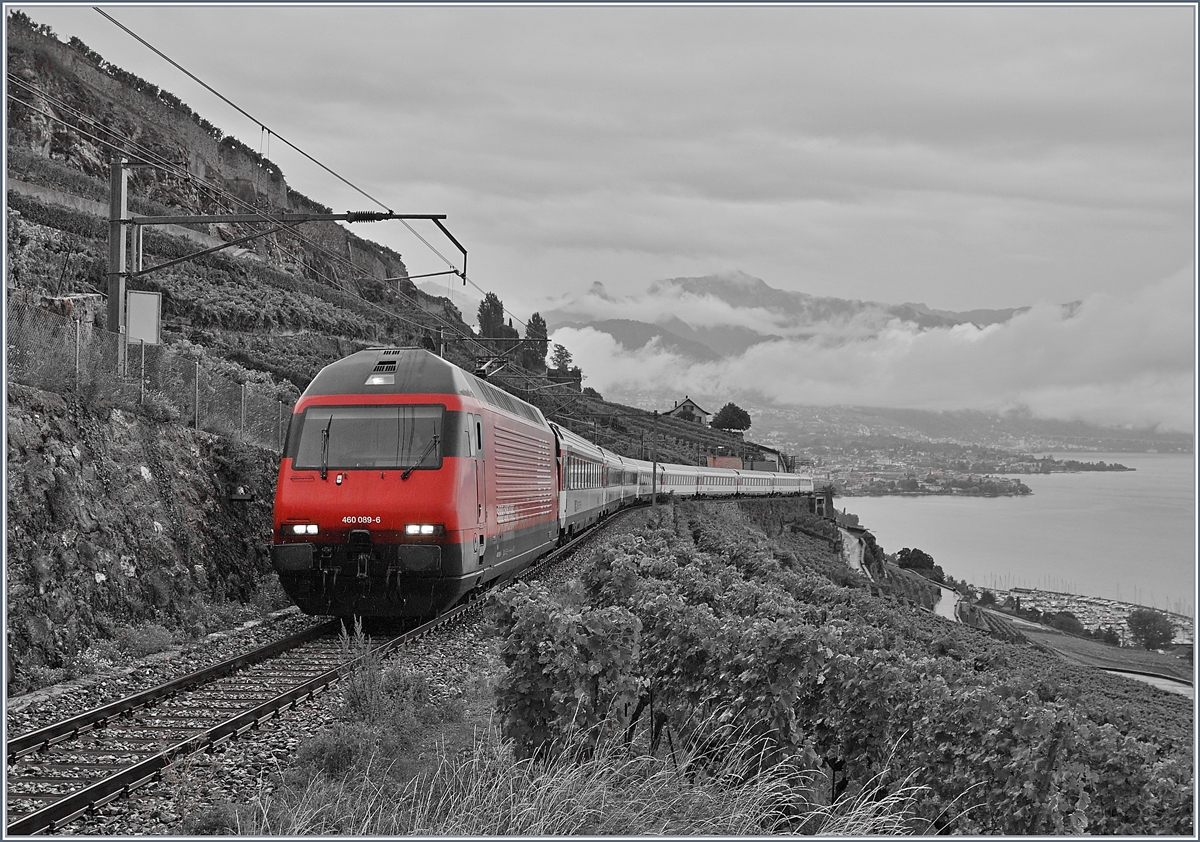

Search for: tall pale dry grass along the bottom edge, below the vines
xmin=238 ymin=729 xmax=918 ymax=837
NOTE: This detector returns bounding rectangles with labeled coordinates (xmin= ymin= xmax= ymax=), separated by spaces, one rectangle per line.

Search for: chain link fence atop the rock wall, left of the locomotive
xmin=6 ymin=297 xmax=294 ymax=451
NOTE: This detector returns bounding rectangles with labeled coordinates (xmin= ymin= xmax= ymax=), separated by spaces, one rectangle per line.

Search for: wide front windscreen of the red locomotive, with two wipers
xmin=293 ymin=405 xmax=444 ymax=470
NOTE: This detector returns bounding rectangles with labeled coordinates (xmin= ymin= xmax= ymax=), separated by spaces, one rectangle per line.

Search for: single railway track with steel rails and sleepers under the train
xmin=5 ymin=517 xmax=616 ymax=836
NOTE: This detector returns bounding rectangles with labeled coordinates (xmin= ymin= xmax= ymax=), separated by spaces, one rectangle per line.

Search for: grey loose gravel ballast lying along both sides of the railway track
xmin=10 ymin=513 xmax=644 ymax=836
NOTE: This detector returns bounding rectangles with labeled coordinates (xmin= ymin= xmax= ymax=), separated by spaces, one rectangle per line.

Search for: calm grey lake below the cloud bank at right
xmin=834 ymin=452 xmax=1196 ymax=617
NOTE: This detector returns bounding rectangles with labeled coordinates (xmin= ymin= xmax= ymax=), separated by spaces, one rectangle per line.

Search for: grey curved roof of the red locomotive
xmin=302 ymin=348 xmax=547 ymax=427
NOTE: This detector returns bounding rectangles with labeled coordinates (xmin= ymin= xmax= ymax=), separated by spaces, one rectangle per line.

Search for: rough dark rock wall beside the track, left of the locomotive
xmin=5 ymin=384 xmax=277 ymax=681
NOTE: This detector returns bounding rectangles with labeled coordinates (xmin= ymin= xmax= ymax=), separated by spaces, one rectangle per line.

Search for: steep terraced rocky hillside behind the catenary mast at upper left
xmin=6 ymin=16 xmax=470 ymax=385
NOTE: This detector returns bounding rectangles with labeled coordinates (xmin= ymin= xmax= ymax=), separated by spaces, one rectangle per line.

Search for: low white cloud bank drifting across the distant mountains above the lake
xmin=551 ymin=269 xmax=1195 ymax=431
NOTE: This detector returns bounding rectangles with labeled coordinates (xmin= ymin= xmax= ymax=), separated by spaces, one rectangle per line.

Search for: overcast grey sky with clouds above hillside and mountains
xmin=14 ymin=4 xmax=1196 ymax=429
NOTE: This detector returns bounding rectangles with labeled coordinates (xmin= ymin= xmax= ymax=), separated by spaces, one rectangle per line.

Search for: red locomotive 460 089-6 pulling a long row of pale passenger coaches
xmin=271 ymin=348 xmax=812 ymax=619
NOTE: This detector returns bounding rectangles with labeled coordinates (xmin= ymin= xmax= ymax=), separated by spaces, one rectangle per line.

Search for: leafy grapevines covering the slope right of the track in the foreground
xmin=498 ymin=503 xmax=1193 ymax=835
